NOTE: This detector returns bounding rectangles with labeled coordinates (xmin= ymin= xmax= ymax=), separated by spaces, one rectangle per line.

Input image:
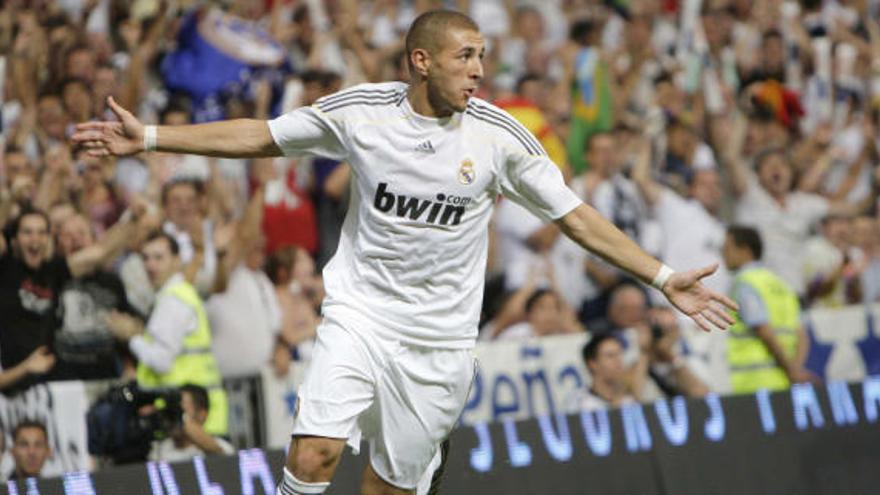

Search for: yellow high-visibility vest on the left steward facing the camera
xmin=137 ymin=281 xmax=229 ymax=435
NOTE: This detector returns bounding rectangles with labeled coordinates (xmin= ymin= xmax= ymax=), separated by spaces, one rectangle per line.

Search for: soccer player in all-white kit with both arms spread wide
xmin=74 ymin=7 xmax=735 ymax=495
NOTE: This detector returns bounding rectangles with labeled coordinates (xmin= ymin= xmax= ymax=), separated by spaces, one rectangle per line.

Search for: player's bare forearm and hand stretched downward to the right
xmin=556 ymin=204 xmax=737 ymax=331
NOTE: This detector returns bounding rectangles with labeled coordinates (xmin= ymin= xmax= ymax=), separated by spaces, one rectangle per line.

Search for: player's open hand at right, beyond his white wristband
xmin=663 ymin=264 xmax=739 ymax=332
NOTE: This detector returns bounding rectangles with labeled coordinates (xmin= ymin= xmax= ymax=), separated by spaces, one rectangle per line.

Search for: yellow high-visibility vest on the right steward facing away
xmin=727 ymin=267 xmax=801 ymax=394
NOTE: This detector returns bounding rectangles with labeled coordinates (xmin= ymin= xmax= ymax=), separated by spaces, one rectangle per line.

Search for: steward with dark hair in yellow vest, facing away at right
xmin=722 ymin=226 xmax=812 ymax=393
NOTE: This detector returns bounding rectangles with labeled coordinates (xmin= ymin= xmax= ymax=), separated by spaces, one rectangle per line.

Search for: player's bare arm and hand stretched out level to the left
xmin=73 ymin=97 xmax=282 ymax=158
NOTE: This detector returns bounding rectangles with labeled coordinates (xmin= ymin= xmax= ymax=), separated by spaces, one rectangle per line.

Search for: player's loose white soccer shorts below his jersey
xmin=293 ymin=318 xmax=475 ymax=490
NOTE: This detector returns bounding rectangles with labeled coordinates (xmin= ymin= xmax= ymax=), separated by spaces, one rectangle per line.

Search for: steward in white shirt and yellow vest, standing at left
xmin=107 ymin=232 xmax=228 ymax=435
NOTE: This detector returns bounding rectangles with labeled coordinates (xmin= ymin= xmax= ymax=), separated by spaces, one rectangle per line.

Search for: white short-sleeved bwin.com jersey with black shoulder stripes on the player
xmin=269 ymin=82 xmax=581 ymax=348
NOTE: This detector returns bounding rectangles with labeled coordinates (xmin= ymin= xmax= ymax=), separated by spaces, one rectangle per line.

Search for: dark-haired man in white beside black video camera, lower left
xmin=150 ymin=384 xmax=235 ymax=462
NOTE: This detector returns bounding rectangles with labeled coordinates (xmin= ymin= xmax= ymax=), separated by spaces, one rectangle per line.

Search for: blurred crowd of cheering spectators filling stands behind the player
xmin=0 ymin=0 xmax=880 ymax=476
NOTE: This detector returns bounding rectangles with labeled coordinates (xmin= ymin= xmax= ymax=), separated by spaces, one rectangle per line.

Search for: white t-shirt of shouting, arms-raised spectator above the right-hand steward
xmin=736 ymin=174 xmax=829 ymax=294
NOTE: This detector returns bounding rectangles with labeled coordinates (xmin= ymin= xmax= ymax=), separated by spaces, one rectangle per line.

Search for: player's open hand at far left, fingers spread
xmin=72 ymin=96 xmax=144 ymax=156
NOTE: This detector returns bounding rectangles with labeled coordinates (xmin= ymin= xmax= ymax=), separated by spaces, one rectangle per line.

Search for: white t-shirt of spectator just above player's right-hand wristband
xmin=654 ymin=188 xmax=730 ymax=294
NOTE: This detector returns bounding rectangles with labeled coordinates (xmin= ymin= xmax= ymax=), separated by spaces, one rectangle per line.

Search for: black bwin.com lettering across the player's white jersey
xmin=373 ymin=182 xmax=473 ymax=225
